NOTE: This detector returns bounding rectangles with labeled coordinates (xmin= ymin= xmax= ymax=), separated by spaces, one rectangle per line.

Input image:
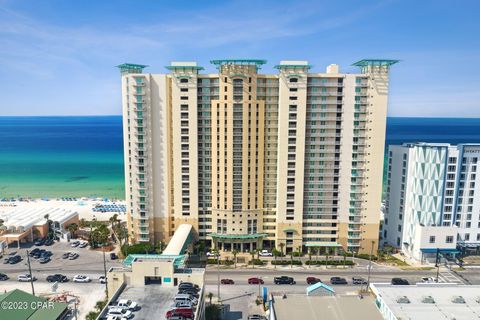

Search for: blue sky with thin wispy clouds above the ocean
xmin=0 ymin=0 xmax=480 ymax=117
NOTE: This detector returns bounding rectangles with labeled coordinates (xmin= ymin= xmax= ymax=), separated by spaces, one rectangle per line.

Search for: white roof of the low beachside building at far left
xmin=0 ymin=206 xmax=78 ymax=233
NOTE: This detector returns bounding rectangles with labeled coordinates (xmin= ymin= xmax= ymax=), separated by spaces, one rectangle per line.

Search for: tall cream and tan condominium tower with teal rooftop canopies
xmin=119 ymin=60 xmax=397 ymax=252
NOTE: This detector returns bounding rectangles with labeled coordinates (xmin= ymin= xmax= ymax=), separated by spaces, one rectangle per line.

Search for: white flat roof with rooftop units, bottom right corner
xmin=371 ymin=283 xmax=480 ymax=320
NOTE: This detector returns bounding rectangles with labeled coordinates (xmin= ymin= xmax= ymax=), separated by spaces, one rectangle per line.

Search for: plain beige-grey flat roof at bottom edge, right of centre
xmin=273 ymin=294 xmax=383 ymax=320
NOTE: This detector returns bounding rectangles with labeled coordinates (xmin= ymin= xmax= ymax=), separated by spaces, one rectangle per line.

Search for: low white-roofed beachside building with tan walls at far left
xmin=0 ymin=207 xmax=79 ymax=247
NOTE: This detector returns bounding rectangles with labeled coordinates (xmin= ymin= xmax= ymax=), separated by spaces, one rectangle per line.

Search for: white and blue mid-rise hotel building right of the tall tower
xmin=382 ymin=143 xmax=480 ymax=261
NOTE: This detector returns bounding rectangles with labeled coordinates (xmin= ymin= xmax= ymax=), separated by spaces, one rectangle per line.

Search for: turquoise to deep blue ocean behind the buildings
xmin=0 ymin=116 xmax=480 ymax=199
